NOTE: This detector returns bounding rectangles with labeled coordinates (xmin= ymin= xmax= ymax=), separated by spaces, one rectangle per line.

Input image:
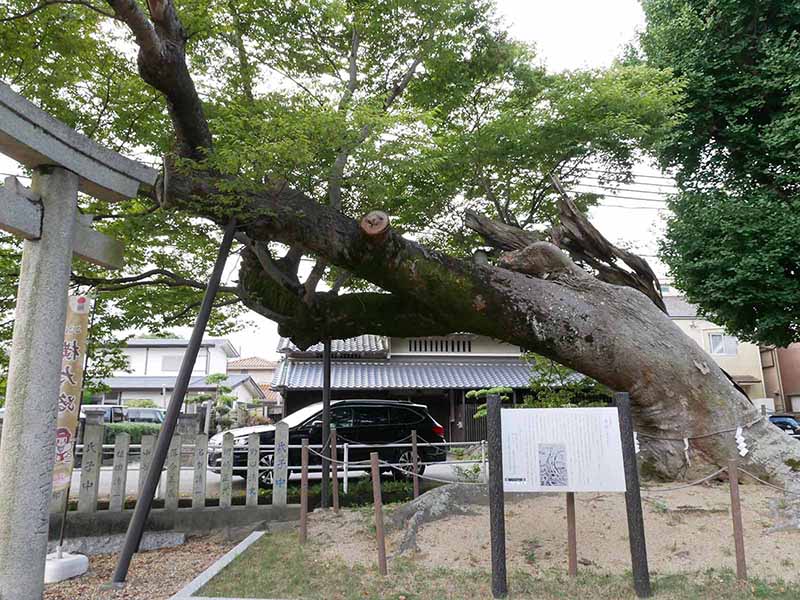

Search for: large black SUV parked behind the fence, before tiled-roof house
xmin=208 ymin=400 xmax=447 ymax=487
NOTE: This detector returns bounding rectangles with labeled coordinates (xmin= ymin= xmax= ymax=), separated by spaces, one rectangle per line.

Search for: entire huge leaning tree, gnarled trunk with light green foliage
xmin=0 ymin=0 xmax=800 ymax=483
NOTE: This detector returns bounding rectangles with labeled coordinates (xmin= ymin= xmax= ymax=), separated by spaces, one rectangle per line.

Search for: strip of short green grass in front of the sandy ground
xmin=198 ymin=533 xmax=800 ymax=600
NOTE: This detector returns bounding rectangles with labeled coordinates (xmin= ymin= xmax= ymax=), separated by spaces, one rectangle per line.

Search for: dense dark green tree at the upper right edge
xmin=640 ymin=0 xmax=800 ymax=346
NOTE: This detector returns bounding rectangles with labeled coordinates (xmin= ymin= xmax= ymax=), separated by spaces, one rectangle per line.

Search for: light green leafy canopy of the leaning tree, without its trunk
xmin=0 ymin=0 xmax=679 ymax=376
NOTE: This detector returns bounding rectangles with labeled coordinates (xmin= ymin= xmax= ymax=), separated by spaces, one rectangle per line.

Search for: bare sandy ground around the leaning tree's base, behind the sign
xmin=309 ymin=484 xmax=800 ymax=581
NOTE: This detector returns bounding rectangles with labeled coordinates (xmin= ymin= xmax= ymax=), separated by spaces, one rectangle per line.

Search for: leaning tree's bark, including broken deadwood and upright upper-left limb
xmin=108 ymin=0 xmax=800 ymax=489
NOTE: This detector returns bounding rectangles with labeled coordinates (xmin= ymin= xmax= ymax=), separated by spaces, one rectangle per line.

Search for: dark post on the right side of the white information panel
xmin=614 ymin=392 xmax=651 ymax=598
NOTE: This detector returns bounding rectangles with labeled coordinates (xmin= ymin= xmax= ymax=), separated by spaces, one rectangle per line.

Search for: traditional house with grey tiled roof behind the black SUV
xmin=272 ymin=333 xmax=531 ymax=441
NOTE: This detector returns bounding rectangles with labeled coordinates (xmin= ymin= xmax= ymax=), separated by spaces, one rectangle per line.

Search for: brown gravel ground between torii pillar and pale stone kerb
xmin=44 ymin=537 xmax=235 ymax=600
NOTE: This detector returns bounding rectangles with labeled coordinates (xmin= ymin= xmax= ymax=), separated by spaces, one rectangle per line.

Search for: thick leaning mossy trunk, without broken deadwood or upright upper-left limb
xmin=169 ymin=175 xmax=800 ymax=490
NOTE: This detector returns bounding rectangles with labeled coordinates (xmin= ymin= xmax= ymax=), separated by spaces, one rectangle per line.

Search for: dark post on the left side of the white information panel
xmin=486 ymin=394 xmax=508 ymax=598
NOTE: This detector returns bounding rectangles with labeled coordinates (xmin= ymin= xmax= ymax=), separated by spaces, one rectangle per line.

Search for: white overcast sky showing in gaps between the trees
xmin=0 ymin=0 xmax=668 ymax=359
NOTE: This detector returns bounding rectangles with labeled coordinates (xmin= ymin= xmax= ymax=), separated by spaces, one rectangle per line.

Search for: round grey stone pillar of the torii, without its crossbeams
xmin=0 ymin=167 xmax=78 ymax=600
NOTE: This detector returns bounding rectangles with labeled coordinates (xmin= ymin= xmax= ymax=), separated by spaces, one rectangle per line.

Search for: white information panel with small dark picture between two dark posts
xmin=500 ymin=408 xmax=625 ymax=492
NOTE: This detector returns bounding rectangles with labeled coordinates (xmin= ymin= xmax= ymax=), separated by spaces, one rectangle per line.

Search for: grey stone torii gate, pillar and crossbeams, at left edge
xmin=0 ymin=82 xmax=158 ymax=600
